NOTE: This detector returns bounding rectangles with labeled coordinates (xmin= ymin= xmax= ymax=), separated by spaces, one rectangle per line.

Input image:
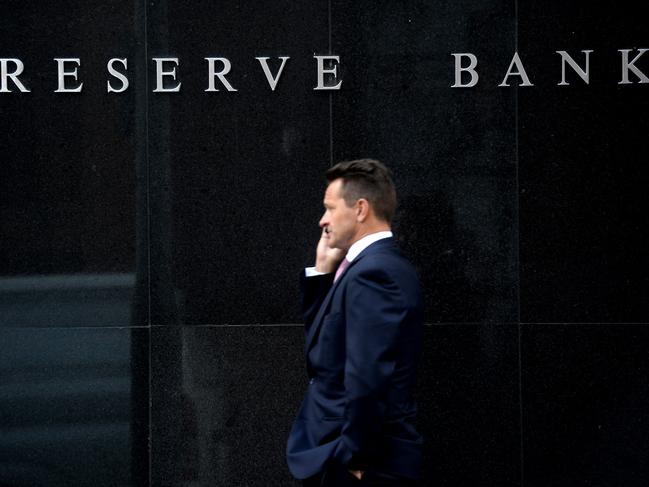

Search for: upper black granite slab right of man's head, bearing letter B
xmin=332 ymin=1 xmax=518 ymax=322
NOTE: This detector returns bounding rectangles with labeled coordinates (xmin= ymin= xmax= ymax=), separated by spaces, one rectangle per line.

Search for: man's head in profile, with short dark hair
xmin=320 ymin=159 xmax=397 ymax=251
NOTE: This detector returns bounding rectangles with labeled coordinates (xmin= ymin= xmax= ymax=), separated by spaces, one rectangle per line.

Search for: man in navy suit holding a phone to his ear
xmin=286 ymin=159 xmax=423 ymax=487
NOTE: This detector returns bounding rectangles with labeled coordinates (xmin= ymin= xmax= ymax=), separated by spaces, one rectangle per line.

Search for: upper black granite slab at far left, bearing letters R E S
xmin=0 ymin=1 xmax=137 ymax=326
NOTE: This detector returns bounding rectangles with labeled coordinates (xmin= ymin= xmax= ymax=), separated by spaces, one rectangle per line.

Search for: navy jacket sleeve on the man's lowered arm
xmin=335 ymin=269 xmax=408 ymax=469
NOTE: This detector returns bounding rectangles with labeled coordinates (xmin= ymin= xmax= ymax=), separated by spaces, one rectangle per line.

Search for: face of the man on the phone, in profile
xmin=320 ymin=178 xmax=357 ymax=251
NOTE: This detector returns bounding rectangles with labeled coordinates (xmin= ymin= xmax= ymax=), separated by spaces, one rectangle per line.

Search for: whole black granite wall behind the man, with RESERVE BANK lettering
xmin=0 ymin=0 xmax=649 ymax=487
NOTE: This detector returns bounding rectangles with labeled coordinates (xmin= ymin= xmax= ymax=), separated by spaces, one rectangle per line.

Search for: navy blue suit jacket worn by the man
xmin=286 ymin=238 xmax=423 ymax=479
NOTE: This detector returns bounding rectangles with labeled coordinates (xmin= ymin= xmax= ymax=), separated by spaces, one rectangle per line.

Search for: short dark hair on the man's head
xmin=325 ymin=159 xmax=397 ymax=223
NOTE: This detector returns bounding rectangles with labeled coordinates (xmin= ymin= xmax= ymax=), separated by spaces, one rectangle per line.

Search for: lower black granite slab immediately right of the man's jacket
xmin=417 ymin=324 xmax=521 ymax=487
